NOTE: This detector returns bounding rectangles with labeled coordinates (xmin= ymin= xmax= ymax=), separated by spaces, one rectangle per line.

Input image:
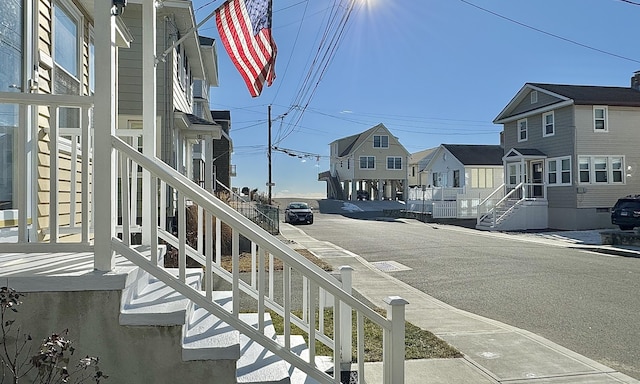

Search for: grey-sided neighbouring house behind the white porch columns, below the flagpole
xmin=117 ymin=1 xmax=222 ymax=225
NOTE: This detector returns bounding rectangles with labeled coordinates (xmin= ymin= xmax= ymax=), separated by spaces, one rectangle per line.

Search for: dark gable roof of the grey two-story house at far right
xmin=493 ymin=83 xmax=640 ymax=124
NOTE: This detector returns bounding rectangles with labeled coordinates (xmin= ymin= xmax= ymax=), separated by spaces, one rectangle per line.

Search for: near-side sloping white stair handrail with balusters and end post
xmin=111 ymin=135 xmax=406 ymax=384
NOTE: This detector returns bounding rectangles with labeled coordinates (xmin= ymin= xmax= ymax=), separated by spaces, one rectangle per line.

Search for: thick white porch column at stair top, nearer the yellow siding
xmin=93 ymin=0 xmax=117 ymax=271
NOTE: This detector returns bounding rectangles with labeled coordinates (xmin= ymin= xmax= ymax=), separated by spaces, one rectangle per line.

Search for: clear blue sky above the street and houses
xmin=193 ymin=0 xmax=640 ymax=197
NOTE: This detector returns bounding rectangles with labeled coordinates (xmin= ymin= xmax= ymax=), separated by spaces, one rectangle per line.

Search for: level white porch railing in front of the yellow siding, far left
xmin=0 ymin=92 xmax=93 ymax=252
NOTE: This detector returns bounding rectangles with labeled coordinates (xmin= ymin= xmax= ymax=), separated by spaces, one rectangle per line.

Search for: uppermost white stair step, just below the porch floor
xmin=120 ymin=269 xmax=202 ymax=326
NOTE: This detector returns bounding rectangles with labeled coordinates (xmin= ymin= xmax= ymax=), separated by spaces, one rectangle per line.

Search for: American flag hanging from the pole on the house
xmin=216 ymin=0 xmax=276 ymax=97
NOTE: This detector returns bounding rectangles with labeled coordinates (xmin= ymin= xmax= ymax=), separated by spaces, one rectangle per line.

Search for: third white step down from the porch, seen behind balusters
xmin=236 ymin=313 xmax=291 ymax=384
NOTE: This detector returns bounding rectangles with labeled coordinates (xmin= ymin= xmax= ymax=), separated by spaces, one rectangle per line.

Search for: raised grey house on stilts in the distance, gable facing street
xmin=319 ymin=124 xmax=409 ymax=200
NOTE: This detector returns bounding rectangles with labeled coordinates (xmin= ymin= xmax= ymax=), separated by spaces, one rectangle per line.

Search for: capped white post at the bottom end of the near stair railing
xmin=383 ymin=296 xmax=409 ymax=384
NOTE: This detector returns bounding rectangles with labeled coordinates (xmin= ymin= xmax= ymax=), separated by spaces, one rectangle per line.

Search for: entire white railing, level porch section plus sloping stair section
xmin=0 ymin=93 xmax=406 ymax=383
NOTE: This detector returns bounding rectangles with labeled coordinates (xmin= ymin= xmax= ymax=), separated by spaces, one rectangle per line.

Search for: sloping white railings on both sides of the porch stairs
xmin=112 ymin=137 xmax=406 ymax=383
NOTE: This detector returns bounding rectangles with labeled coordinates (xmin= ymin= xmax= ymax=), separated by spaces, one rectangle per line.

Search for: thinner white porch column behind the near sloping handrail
xmin=142 ymin=0 xmax=157 ymax=245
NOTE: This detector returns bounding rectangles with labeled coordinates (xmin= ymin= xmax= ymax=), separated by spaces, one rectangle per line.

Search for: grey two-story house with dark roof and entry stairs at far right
xmin=484 ymin=72 xmax=640 ymax=230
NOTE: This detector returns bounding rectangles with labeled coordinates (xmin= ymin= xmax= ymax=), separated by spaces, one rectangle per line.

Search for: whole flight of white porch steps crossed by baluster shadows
xmin=119 ymin=268 xmax=333 ymax=384
